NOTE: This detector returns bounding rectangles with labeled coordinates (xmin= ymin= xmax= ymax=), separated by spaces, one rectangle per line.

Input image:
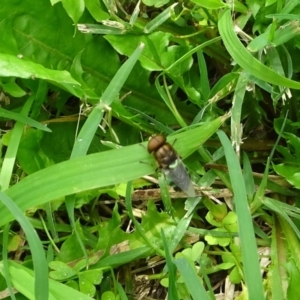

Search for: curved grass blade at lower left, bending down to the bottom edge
xmin=0 ymin=192 xmax=49 ymax=300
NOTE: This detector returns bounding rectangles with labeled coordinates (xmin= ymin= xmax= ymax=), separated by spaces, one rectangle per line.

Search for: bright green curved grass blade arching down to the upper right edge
xmin=218 ymin=9 xmax=300 ymax=89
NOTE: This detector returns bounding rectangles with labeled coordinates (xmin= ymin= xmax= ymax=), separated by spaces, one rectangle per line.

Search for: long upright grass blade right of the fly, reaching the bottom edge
xmin=217 ymin=131 xmax=265 ymax=300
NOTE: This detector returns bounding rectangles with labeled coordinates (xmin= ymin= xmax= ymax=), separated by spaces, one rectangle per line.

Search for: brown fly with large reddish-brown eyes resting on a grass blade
xmin=148 ymin=134 xmax=195 ymax=197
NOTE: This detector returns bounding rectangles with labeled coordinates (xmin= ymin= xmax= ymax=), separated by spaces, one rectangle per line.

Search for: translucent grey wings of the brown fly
xmin=164 ymin=158 xmax=196 ymax=197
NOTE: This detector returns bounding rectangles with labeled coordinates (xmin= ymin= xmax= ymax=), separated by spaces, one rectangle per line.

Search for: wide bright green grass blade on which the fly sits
xmin=0 ymin=117 xmax=226 ymax=226
